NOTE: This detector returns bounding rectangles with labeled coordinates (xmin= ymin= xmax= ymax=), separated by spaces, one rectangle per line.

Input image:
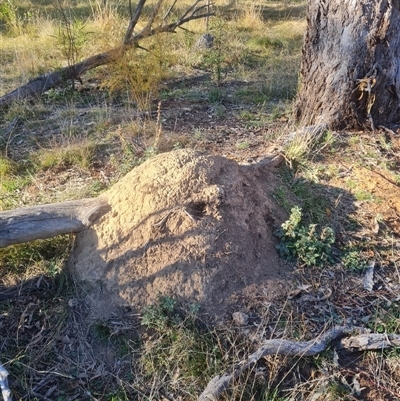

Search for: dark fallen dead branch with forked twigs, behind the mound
xmin=0 ymin=0 xmax=214 ymax=109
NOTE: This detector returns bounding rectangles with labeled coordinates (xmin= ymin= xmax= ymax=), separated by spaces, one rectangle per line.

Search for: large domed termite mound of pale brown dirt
xmin=69 ymin=150 xmax=287 ymax=316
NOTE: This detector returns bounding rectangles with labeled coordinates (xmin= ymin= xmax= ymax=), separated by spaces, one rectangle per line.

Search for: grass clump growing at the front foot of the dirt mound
xmin=140 ymin=297 xmax=222 ymax=395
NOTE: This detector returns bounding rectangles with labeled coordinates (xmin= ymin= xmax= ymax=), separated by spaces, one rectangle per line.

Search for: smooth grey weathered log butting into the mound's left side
xmin=0 ymin=197 xmax=110 ymax=248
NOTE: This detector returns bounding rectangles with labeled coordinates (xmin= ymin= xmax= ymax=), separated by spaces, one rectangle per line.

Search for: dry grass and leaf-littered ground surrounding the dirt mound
xmin=0 ymin=0 xmax=400 ymax=401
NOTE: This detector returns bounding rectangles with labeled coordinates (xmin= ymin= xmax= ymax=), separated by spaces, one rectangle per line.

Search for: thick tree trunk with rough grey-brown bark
xmin=295 ymin=0 xmax=400 ymax=130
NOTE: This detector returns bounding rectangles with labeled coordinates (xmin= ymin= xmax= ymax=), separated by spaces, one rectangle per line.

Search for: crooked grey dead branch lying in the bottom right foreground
xmin=198 ymin=326 xmax=400 ymax=401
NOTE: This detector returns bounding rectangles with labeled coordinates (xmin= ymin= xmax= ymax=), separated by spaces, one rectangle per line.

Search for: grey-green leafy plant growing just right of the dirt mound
xmin=276 ymin=206 xmax=335 ymax=266
